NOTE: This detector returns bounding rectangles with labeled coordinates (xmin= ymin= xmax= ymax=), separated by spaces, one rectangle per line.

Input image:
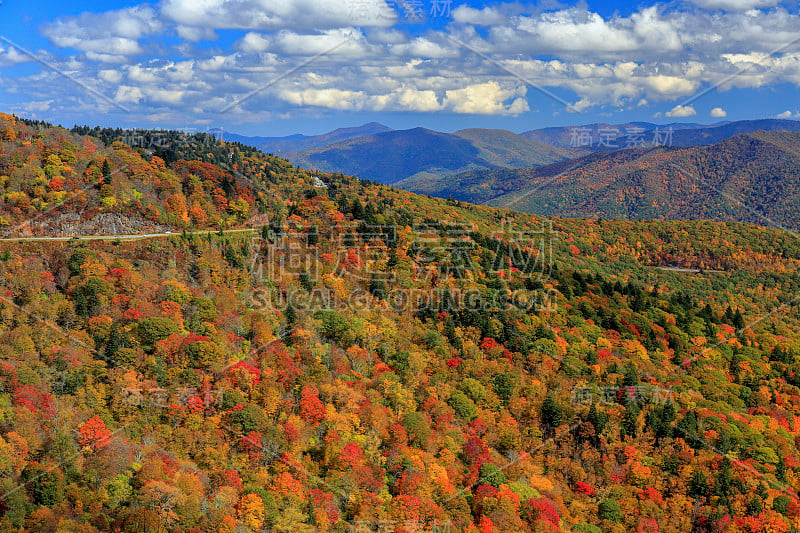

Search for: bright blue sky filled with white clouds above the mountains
xmin=0 ymin=0 xmax=800 ymax=136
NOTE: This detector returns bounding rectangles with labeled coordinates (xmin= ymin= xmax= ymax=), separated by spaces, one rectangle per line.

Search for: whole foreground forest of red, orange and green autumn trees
xmin=0 ymin=116 xmax=800 ymax=533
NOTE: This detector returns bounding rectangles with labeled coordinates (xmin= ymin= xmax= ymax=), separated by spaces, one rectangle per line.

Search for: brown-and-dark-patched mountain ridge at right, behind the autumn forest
xmin=424 ymin=131 xmax=800 ymax=228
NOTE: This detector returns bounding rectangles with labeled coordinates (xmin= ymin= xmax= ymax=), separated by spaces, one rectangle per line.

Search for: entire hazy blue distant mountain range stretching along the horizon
xmin=210 ymin=119 xmax=800 ymax=193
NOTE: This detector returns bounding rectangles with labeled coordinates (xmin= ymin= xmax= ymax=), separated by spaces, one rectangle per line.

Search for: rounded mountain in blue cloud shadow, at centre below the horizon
xmin=283 ymin=128 xmax=580 ymax=183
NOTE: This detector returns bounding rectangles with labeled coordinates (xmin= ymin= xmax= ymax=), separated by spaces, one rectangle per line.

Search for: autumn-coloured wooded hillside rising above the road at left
xmin=0 ymin=115 xmax=313 ymax=235
